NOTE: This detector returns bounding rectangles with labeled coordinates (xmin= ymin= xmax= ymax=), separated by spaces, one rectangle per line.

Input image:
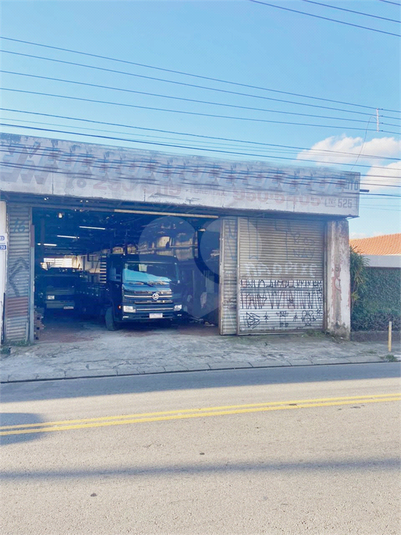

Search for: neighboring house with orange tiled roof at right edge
xmin=350 ymin=233 xmax=401 ymax=268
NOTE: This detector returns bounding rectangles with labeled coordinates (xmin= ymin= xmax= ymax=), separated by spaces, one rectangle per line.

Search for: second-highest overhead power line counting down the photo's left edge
xmin=0 ymin=69 xmax=384 ymax=126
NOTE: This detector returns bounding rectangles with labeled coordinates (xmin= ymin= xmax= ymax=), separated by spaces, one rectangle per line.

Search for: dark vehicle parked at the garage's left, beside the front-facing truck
xmin=35 ymin=268 xmax=82 ymax=311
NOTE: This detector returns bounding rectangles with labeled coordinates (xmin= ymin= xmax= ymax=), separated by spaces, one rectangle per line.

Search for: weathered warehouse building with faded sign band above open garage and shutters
xmin=0 ymin=134 xmax=360 ymax=342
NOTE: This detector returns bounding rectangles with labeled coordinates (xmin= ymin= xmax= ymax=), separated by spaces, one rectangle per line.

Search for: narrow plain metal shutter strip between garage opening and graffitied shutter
xmin=219 ymin=217 xmax=238 ymax=335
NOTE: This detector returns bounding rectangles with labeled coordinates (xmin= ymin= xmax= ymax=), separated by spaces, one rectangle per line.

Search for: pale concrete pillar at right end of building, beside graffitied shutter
xmin=326 ymin=219 xmax=351 ymax=340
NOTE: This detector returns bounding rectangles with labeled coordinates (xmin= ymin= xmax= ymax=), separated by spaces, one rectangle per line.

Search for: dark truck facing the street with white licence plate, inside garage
xmin=81 ymin=254 xmax=182 ymax=330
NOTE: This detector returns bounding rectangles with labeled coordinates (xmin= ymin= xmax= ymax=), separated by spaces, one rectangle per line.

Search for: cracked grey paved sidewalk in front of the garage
xmin=0 ymin=323 xmax=401 ymax=383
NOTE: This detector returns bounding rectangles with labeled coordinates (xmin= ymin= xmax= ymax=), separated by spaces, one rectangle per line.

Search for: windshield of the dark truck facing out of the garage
xmin=123 ymin=262 xmax=177 ymax=284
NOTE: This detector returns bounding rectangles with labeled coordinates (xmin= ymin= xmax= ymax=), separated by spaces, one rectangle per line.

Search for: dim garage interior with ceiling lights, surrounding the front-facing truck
xmin=32 ymin=199 xmax=220 ymax=341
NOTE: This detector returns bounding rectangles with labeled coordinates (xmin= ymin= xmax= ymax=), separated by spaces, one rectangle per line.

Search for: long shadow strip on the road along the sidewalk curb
xmin=1 ymin=362 xmax=401 ymax=403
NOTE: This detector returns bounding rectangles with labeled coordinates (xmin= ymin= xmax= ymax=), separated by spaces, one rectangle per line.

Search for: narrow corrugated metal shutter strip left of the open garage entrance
xmin=5 ymin=204 xmax=32 ymax=342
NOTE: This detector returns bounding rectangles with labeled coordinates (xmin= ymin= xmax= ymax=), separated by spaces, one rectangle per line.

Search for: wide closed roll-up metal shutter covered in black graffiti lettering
xmin=238 ymin=218 xmax=324 ymax=334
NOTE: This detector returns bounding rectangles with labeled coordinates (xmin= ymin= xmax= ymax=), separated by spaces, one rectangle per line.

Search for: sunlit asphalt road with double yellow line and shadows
xmin=0 ymin=363 xmax=401 ymax=535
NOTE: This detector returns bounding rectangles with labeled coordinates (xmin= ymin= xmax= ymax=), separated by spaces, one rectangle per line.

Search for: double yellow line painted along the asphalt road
xmin=0 ymin=393 xmax=401 ymax=436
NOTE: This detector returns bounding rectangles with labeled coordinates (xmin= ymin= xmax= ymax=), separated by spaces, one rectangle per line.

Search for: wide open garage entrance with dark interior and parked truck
xmin=32 ymin=205 xmax=220 ymax=341
